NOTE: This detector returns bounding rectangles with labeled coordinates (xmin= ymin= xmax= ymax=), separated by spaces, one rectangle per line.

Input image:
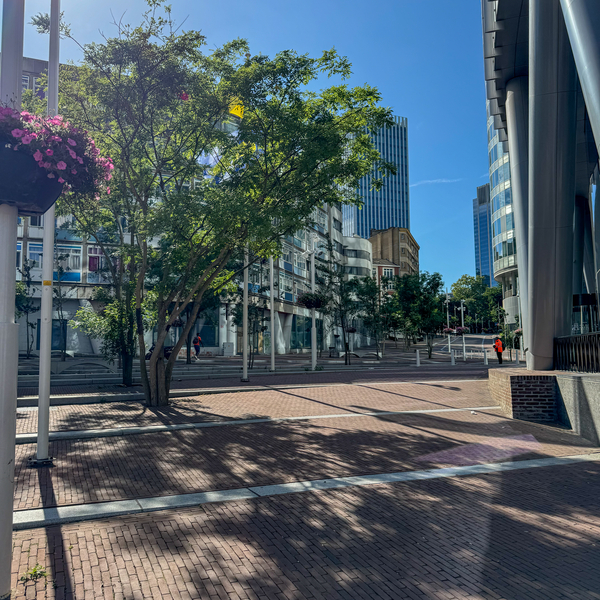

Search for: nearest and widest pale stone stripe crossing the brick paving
xmin=13 ymin=452 xmax=600 ymax=529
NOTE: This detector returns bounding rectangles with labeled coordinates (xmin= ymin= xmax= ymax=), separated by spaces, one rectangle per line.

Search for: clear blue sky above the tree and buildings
xmin=16 ymin=0 xmax=488 ymax=286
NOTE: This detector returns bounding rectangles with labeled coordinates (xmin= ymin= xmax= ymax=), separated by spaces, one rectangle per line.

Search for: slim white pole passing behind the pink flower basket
xmin=36 ymin=0 xmax=60 ymax=465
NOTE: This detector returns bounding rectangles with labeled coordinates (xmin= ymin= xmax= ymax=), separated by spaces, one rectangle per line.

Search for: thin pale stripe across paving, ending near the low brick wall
xmin=15 ymin=406 xmax=500 ymax=445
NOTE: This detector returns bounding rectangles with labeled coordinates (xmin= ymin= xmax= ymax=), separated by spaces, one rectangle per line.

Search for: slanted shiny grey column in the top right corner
xmin=560 ymin=0 xmax=600 ymax=154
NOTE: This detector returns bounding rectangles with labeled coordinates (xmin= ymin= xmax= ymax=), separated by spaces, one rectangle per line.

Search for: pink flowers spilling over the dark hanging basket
xmin=0 ymin=107 xmax=114 ymax=196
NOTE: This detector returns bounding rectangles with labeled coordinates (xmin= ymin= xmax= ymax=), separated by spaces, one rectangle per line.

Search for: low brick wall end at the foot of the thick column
xmin=489 ymin=369 xmax=557 ymax=422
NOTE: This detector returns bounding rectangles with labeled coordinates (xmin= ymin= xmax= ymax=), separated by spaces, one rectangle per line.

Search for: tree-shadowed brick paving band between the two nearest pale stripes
xmin=15 ymin=404 xmax=594 ymax=510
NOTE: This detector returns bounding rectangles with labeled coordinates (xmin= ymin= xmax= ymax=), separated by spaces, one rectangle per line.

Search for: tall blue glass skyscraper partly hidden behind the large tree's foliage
xmin=342 ymin=117 xmax=410 ymax=239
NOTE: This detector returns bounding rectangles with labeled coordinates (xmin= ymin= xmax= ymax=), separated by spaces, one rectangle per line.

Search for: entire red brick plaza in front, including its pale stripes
xmin=8 ymin=368 xmax=600 ymax=600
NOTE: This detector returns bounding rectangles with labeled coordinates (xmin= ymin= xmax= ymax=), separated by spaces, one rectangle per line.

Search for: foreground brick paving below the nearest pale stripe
xmin=13 ymin=463 xmax=600 ymax=600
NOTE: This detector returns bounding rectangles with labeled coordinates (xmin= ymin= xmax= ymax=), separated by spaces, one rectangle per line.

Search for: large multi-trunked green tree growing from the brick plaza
xmin=55 ymin=0 xmax=394 ymax=405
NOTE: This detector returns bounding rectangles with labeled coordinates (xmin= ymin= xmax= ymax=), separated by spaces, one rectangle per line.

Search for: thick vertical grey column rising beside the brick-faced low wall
xmin=527 ymin=0 xmax=577 ymax=370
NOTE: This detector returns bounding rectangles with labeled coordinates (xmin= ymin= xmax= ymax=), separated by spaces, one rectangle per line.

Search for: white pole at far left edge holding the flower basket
xmin=0 ymin=0 xmax=25 ymax=600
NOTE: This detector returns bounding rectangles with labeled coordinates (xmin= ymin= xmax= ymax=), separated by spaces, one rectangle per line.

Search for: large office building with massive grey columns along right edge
xmin=481 ymin=0 xmax=600 ymax=370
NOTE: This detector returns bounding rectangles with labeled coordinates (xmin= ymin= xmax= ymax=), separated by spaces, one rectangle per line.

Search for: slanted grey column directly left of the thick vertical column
xmin=506 ymin=77 xmax=529 ymax=348
